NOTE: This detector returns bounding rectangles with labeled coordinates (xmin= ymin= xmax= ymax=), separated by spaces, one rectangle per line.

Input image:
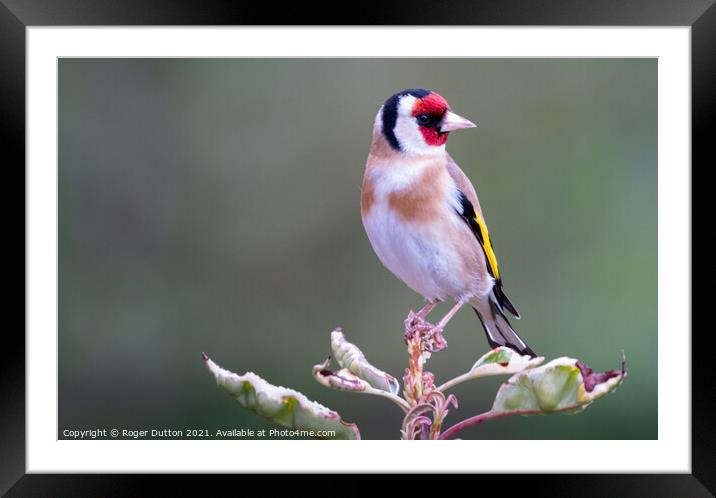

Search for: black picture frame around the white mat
xmin=0 ymin=0 xmax=716 ymax=497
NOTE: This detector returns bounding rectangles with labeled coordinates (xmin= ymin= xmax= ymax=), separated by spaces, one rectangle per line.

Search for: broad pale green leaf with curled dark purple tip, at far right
xmin=490 ymin=358 xmax=627 ymax=415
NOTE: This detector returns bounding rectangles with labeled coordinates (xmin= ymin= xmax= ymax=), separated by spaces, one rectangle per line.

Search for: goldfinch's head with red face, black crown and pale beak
xmin=377 ymin=88 xmax=475 ymax=155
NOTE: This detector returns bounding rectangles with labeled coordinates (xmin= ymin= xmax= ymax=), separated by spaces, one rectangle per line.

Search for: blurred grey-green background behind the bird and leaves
xmin=59 ymin=59 xmax=657 ymax=439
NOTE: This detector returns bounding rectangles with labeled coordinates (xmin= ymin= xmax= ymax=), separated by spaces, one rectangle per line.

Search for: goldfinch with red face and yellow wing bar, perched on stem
xmin=360 ymin=88 xmax=536 ymax=357
